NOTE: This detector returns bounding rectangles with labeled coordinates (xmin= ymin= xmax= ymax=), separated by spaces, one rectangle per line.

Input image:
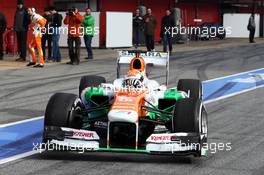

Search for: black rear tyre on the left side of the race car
xmin=79 ymin=75 xmax=106 ymax=96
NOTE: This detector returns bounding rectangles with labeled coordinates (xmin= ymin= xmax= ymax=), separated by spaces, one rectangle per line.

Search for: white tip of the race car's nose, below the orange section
xmin=108 ymin=110 xmax=138 ymax=123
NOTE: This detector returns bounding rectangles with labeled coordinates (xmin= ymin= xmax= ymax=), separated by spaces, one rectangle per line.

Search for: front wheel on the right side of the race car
xmin=172 ymin=98 xmax=208 ymax=156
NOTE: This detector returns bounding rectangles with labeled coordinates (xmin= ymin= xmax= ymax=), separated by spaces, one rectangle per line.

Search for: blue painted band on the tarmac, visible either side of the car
xmin=0 ymin=68 xmax=264 ymax=161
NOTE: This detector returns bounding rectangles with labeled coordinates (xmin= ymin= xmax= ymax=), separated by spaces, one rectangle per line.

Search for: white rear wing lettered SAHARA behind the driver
xmin=117 ymin=50 xmax=170 ymax=86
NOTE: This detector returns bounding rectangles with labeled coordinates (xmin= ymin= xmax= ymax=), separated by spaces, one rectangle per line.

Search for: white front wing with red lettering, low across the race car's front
xmin=42 ymin=127 xmax=208 ymax=156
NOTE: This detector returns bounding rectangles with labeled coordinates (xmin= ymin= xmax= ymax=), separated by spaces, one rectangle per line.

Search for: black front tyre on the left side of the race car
xmin=44 ymin=93 xmax=83 ymax=129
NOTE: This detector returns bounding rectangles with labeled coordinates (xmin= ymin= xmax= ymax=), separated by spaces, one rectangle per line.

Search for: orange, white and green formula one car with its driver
xmin=43 ymin=51 xmax=207 ymax=156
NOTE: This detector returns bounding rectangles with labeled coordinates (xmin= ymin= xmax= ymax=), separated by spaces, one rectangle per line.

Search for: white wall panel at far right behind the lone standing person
xmin=223 ymin=13 xmax=260 ymax=38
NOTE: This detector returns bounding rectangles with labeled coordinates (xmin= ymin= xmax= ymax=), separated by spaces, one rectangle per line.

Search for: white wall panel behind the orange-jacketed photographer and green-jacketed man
xmin=60 ymin=12 xmax=100 ymax=47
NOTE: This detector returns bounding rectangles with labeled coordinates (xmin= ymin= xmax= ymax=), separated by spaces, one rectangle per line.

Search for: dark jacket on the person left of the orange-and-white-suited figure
xmin=14 ymin=6 xmax=31 ymax=32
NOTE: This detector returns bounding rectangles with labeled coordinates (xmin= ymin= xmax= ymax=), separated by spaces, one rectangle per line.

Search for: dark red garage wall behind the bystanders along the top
xmin=0 ymin=0 xmax=220 ymax=46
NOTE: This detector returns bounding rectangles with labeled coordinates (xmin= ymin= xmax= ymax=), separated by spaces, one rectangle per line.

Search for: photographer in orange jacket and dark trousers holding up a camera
xmin=63 ymin=7 xmax=83 ymax=65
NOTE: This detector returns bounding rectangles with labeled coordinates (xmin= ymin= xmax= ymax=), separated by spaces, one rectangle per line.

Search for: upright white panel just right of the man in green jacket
xmin=106 ymin=12 xmax=133 ymax=48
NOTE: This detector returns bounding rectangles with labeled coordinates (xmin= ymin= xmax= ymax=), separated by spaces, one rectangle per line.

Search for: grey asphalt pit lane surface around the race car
xmin=0 ymin=44 xmax=264 ymax=175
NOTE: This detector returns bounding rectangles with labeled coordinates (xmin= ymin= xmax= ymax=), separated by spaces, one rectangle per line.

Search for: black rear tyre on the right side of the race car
xmin=177 ymin=79 xmax=202 ymax=101
